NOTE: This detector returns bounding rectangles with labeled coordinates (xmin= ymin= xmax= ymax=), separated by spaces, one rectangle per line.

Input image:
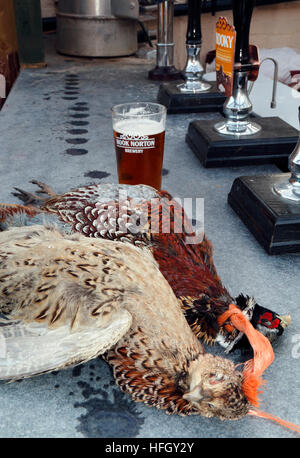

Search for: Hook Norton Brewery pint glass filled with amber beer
xmin=112 ymin=102 xmax=166 ymax=190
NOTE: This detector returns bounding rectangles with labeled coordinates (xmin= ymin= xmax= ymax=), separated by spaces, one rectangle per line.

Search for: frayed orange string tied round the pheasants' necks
xmin=218 ymin=304 xmax=300 ymax=433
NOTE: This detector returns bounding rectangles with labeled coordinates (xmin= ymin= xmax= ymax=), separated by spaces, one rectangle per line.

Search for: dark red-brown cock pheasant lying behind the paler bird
xmin=9 ymin=181 xmax=290 ymax=352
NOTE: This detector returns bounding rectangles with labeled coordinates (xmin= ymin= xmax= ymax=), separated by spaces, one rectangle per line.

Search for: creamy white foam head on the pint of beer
xmin=114 ymin=119 xmax=165 ymax=136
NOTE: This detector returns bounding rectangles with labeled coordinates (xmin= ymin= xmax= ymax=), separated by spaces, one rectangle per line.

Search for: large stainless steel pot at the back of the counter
xmin=56 ymin=0 xmax=139 ymax=57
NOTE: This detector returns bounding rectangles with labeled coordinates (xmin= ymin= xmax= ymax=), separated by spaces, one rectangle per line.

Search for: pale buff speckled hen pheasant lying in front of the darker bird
xmin=0 ymin=225 xmax=273 ymax=420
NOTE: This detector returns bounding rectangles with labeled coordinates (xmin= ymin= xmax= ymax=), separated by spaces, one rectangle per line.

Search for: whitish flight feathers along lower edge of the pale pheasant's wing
xmin=0 ymin=310 xmax=131 ymax=380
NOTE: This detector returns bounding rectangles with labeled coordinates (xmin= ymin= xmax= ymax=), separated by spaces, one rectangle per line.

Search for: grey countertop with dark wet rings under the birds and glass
xmin=0 ymin=36 xmax=300 ymax=438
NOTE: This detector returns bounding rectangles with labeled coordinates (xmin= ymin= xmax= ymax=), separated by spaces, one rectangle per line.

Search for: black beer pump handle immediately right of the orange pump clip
xmin=232 ymin=0 xmax=255 ymax=65
